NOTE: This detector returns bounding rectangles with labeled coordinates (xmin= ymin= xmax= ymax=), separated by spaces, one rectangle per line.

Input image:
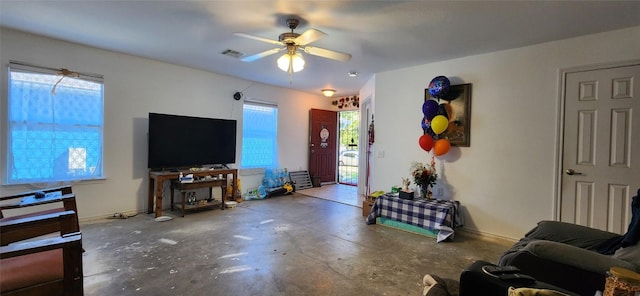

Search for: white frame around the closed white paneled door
xmin=553 ymin=59 xmax=640 ymax=221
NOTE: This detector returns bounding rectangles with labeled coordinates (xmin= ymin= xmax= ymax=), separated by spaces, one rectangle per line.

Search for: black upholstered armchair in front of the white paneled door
xmin=498 ymin=221 xmax=640 ymax=295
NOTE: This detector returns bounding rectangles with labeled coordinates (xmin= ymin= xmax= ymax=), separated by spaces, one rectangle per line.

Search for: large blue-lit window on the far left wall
xmin=6 ymin=62 xmax=104 ymax=184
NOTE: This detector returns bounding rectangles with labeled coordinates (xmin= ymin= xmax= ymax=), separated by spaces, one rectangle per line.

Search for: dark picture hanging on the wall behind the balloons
xmin=424 ymin=83 xmax=471 ymax=147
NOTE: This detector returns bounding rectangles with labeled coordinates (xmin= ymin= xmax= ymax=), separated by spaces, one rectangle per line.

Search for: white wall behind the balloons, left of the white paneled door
xmin=370 ymin=27 xmax=640 ymax=238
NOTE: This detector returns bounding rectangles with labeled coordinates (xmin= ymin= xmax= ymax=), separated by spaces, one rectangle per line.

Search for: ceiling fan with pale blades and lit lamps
xmin=235 ymin=18 xmax=351 ymax=73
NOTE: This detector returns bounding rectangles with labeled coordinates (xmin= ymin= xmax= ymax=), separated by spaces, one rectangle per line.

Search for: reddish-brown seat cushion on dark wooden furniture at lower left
xmin=0 ymin=249 xmax=64 ymax=294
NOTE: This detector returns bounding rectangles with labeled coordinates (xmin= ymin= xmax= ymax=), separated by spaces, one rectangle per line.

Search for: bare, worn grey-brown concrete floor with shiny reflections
xmin=81 ymin=194 xmax=508 ymax=296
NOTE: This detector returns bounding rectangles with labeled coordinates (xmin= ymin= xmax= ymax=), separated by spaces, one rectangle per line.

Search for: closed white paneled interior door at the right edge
xmin=560 ymin=63 xmax=640 ymax=233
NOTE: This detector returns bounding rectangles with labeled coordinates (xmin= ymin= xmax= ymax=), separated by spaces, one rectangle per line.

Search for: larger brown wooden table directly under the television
xmin=147 ymin=169 xmax=238 ymax=218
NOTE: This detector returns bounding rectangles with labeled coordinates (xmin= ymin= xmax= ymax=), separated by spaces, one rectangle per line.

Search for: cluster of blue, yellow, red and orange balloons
xmin=418 ymin=76 xmax=451 ymax=156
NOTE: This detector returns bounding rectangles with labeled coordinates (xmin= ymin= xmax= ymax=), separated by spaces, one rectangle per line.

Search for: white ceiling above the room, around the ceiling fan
xmin=0 ymin=0 xmax=640 ymax=96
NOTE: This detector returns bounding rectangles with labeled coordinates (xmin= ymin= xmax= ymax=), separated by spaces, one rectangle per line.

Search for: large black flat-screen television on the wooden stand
xmin=147 ymin=113 xmax=237 ymax=170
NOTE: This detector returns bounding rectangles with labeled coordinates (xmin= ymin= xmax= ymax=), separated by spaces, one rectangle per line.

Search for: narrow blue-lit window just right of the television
xmin=241 ymin=102 xmax=278 ymax=169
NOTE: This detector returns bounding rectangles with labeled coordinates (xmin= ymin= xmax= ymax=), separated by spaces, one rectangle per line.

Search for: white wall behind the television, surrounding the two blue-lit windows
xmin=0 ymin=28 xmax=331 ymax=219
